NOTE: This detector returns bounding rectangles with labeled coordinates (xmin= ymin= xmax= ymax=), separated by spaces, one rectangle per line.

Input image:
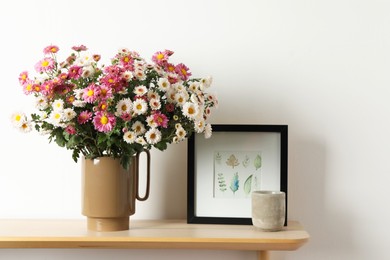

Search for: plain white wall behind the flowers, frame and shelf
xmin=0 ymin=0 xmax=390 ymax=260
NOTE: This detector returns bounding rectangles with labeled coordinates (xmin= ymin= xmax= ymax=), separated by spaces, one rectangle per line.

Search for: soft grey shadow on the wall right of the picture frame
xmin=279 ymin=137 xmax=356 ymax=259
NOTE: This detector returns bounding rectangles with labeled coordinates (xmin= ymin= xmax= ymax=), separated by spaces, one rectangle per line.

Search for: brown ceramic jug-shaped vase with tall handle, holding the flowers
xmin=82 ymin=151 xmax=150 ymax=232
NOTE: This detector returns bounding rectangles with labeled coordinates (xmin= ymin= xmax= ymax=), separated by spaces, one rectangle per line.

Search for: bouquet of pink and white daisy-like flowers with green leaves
xmin=12 ymin=45 xmax=218 ymax=168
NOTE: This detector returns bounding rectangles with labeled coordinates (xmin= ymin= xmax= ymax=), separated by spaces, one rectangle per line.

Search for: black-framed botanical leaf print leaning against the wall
xmin=187 ymin=124 xmax=288 ymax=225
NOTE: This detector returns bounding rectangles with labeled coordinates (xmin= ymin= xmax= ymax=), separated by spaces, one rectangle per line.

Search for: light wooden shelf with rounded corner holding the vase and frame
xmin=0 ymin=220 xmax=309 ymax=259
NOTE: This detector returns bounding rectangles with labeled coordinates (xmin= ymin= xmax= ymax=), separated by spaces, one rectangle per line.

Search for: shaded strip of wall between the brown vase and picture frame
xmin=134 ymin=142 xmax=187 ymax=219
